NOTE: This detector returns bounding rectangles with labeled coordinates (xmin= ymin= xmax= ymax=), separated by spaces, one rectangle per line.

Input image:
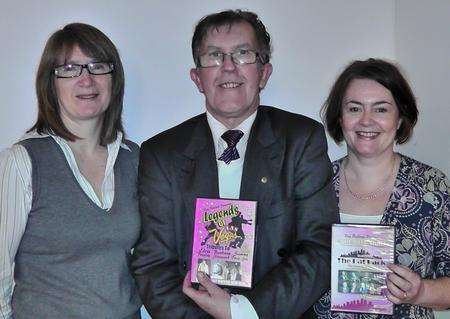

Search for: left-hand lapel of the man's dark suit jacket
xmin=175 ymin=114 xmax=219 ymax=225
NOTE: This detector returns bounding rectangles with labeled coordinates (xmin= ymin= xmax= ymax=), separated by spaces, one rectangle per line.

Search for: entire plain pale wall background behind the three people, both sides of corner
xmin=0 ymin=0 xmax=450 ymax=318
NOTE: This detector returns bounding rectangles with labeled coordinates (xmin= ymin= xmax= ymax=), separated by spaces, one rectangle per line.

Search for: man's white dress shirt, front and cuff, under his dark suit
xmin=206 ymin=112 xmax=258 ymax=319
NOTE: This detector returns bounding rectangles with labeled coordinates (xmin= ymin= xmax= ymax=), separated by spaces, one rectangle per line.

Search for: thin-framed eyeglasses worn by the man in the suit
xmin=199 ymin=49 xmax=259 ymax=68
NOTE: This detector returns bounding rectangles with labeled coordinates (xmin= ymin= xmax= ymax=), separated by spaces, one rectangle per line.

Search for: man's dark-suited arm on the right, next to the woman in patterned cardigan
xmin=247 ymin=126 xmax=339 ymax=319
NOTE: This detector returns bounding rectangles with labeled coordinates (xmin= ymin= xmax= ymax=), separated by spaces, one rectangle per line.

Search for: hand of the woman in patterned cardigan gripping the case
xmin=386 ymin=264 xmax=424 ymax=305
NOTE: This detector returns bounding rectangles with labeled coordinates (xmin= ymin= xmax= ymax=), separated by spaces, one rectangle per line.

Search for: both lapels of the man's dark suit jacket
xmin=174 ymin=108 xmax=285 ymax=223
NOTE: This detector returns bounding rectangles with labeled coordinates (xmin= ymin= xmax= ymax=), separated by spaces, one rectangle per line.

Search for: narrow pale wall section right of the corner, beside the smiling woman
xmin=395 ymin=0 xmax=450 ymax=177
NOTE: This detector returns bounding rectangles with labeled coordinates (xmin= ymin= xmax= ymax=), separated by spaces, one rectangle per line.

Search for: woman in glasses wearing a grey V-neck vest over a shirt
xmin=0 ymin=23 xmax=141 ymax=318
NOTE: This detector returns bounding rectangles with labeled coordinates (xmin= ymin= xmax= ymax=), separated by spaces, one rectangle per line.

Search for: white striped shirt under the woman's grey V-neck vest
xmin=0 ymin=133 xmax=131 ymax=319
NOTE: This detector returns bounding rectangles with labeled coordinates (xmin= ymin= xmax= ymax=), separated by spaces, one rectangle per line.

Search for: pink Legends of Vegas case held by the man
xmin=191 ymin=198 xmax=256 ymax=289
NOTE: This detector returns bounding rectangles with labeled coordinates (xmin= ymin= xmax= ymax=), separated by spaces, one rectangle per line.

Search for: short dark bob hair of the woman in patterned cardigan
xmin=320 ymin=58 xmax=419 ymax=144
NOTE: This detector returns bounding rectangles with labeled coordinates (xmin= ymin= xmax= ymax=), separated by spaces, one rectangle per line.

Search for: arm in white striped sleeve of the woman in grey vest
xmin=0 ymin=146 xmax=32 ymax=319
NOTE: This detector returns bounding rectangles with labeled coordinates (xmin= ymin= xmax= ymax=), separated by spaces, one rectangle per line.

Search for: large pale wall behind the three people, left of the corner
xmin=0 ymin=0 xmax=395 ymax=162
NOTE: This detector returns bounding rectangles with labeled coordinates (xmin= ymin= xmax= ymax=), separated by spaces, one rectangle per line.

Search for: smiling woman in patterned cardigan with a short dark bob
xmin=305 ymin=59 xmax=450 ymax=318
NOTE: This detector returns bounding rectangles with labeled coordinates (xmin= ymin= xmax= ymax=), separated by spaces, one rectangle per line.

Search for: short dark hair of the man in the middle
xmin=192 ymin=10 xmax=271 ymax=66
